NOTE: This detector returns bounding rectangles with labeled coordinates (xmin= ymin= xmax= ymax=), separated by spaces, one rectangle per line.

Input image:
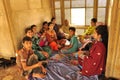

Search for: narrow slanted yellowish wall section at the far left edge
xmin=0 ymin=0 xmax=14 ymax=57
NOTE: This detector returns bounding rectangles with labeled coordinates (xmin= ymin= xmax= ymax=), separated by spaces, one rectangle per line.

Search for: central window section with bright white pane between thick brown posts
xmin=64 ymin=0 xmax=94 ymax=25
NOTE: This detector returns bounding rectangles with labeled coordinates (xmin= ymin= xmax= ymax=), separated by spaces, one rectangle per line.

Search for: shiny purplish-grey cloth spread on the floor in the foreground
xmin=31 ymin=58 xmax=98 ymax=80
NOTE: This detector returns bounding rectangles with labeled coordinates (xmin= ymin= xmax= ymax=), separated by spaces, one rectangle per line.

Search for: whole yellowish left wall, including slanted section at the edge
xmin=0 ymin=0 xmax=52 ymax=57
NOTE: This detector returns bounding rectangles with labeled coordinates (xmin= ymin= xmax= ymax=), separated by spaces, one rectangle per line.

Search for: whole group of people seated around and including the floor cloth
xmin=16 ymin=18 xmax=108 ymax=80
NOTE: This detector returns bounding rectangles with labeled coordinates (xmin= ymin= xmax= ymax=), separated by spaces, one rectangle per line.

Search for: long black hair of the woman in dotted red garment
xmin=95 ymin=25 xmax=108 ymax=49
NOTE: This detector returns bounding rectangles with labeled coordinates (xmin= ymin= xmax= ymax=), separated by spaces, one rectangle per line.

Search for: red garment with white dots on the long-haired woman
xmin=79 ymin=42 xmax=106 ymax=76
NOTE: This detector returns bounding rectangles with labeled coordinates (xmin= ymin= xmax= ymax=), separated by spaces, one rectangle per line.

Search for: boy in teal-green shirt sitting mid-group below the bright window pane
xmin=61 ymin=27 xmax=78 ymax=54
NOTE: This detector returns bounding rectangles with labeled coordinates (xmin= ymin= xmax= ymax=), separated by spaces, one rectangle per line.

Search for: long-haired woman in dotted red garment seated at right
xmin=73 ymin=25 xmax=108 ymax=77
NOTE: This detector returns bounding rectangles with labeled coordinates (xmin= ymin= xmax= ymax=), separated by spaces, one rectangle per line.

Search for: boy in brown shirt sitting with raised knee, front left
xmin=16 ymin=36 xmax=46 ymax=78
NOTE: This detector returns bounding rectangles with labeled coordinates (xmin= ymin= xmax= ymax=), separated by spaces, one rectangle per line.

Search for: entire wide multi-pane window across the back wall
xmin=53 ymin=0 xmax=107 ymax=26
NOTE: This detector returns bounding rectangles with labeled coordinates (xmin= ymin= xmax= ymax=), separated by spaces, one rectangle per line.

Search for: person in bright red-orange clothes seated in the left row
xmin=46 ymin=22 xmax=59 ymax=51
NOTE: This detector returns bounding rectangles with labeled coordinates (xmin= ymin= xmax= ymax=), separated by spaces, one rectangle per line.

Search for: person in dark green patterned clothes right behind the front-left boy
xmin=25 ymin=28 xmax=49 ymax=60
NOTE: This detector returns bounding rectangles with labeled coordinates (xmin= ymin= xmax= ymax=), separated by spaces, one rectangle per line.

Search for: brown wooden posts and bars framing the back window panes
xmin=52 ymin=0 xmax=110 ymax=27
